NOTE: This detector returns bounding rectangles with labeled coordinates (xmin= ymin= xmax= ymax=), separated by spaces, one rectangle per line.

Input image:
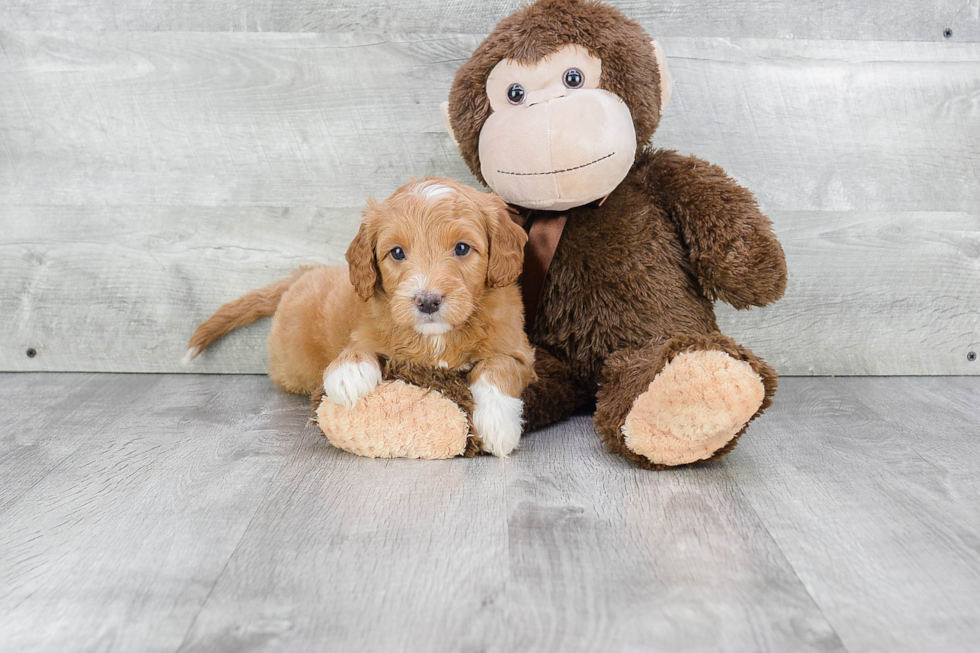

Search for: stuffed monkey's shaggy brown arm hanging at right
xmin=638 ymin=150 xmax=786 ymax=309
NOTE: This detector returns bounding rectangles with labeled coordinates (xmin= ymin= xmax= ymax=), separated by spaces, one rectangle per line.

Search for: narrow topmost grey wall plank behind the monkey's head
xmin=0 ymin=0 xmax=980 ymax=41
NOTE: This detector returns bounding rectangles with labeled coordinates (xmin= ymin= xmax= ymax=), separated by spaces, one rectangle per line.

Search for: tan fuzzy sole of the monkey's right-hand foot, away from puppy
xmin=623 ymin=351 xmax=765 ymax=465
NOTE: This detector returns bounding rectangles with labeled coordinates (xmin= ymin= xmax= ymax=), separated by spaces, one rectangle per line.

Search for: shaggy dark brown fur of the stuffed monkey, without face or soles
xmin=449 ymin=0 xmax=786 ymax=469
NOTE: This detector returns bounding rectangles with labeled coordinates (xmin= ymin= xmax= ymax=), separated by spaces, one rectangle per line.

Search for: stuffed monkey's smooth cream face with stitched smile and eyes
xmin=479 ymin=45 xmax=636 ymax=211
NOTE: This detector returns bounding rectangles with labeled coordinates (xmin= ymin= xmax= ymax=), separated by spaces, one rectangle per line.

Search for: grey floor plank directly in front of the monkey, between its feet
xmin=458 ymin=417 xmax=844 ymax=653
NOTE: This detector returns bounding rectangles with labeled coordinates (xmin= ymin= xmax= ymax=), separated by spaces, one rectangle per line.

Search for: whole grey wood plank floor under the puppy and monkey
xmin=0 ymin=374 xmax=980 ymax=652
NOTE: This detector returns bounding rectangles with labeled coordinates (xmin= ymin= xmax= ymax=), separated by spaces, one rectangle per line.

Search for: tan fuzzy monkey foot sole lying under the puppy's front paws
xmin=316 ymin=381 xmax=469 ymax=460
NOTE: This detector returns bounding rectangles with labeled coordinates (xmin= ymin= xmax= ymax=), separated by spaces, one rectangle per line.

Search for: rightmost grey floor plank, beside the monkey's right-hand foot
xmin=724 ymin=378 xmax=980 ymax=651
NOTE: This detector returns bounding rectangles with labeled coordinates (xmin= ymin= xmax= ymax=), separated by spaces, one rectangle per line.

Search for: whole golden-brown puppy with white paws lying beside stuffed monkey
xmin=188 ymin=177 xmax=535 ymax=456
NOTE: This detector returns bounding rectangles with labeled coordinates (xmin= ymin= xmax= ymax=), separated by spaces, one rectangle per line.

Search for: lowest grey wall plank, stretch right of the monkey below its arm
xmin=717 ymin=212 xmax=980 ymax=376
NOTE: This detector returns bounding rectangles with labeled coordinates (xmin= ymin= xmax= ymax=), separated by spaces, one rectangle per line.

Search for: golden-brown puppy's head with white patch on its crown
xmin=347 ymin=177 xmax=527 ymax=335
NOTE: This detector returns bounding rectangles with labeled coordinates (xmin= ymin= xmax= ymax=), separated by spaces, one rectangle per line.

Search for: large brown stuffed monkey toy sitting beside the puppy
xmin=319 ymin=0 xmax=786 ymax=469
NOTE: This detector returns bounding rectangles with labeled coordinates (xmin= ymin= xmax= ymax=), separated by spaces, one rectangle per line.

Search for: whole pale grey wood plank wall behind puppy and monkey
xmin=0 ymin=0 xmax=980 ymax=375
